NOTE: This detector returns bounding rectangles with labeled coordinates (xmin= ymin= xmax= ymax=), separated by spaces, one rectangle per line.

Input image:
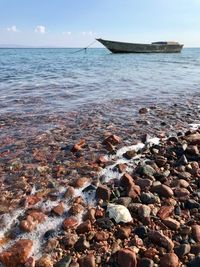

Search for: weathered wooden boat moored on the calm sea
xmin=96 ymin=38 xmax=183 ymax=53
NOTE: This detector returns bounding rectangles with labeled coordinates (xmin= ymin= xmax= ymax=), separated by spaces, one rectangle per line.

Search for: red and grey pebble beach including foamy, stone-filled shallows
xmin=0 ymin=95 xmax=200 ymax=267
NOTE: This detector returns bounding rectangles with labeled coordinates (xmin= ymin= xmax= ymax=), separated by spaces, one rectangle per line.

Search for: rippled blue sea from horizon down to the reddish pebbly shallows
xmin=0 ymin=48 xmax=200 ymax=139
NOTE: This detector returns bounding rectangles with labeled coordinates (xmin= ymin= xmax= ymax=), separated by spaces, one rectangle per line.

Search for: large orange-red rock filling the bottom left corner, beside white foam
xmin=0 ymin=239 xmax=33 ymax=267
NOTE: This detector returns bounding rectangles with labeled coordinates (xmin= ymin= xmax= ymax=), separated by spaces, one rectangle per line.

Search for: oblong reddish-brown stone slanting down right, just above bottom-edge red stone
xmin=149 ymin=231 xmax=174 ymax=251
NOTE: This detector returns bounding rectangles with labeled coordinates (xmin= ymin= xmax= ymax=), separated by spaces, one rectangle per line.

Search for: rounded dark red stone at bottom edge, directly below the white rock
xmin=117 ymin=248 xmax=137 ymax=267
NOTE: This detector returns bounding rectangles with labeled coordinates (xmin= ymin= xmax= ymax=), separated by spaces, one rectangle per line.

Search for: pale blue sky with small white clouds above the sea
xmin=0 ymin=0 xmax=200 ymax=47
